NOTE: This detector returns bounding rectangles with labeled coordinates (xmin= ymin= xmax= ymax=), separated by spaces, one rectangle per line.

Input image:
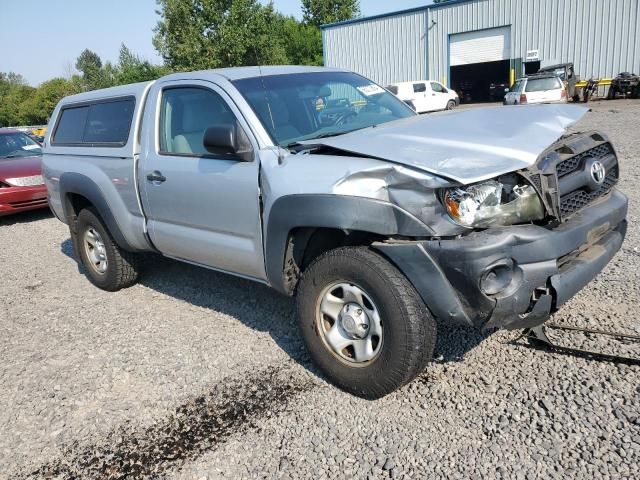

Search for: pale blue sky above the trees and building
xmin=0 ymin=0 xmax=431 ymax=86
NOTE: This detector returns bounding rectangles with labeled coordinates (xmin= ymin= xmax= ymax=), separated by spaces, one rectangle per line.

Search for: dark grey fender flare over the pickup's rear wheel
xmin=60 ymin=172 xmax=135 ymax=251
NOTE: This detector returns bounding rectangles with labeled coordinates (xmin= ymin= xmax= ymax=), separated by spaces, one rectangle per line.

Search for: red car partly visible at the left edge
xmin=0 ymin=128 xmax=48 ymax=216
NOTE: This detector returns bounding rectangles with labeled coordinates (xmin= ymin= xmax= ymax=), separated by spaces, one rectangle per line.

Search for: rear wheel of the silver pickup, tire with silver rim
xmin=72 ymin=208 xmax=138 ymax=292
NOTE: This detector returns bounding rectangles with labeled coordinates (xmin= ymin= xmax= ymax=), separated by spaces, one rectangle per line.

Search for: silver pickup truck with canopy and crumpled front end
xmin=43 ymin=67 xmax=627 ymax=398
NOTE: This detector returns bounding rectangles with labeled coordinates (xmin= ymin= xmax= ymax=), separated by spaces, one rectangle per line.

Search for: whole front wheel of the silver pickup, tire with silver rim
xmin=297 ymin=247 xmax=436 ymax=399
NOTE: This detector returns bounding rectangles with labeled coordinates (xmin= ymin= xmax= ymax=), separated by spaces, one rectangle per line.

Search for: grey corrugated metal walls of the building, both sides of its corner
xmin=323 ymin=0 xmax=640 ymax=83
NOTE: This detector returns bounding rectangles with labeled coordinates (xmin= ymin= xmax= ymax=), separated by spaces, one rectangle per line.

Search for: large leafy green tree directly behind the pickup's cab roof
xmin=153 ymin=0 xmax=287 ymax=70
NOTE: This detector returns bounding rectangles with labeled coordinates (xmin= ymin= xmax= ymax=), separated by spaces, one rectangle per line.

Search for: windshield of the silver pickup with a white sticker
xmin=234 ymin=72 xmax=415 ymax=146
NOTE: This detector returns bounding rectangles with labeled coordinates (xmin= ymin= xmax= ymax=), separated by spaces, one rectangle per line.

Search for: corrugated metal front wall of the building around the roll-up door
xmin=427 ymin=0 xmax=640 ymax=81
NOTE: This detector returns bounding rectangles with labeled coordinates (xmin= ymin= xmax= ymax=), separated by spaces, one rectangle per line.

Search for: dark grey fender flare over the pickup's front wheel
xmin=265 ymin=194 xmax=433 ymax=294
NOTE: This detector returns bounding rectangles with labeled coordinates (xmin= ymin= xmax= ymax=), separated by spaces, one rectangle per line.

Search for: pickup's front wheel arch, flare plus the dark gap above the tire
xmin=265 ymin=194 xmax=433 ymax=295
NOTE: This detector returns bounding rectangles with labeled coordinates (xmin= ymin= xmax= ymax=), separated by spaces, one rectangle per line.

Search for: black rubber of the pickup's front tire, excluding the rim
xmin=298 ymin=249 xmax=435 ymax=398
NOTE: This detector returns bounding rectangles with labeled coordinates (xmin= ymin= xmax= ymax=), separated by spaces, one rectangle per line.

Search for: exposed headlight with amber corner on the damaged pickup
xmin=443 ymin=175 xmax=544 ymax=228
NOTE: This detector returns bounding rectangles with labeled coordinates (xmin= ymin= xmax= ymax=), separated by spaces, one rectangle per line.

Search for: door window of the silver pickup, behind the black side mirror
xmin=160 ymin=87 xmax=237 ymax=156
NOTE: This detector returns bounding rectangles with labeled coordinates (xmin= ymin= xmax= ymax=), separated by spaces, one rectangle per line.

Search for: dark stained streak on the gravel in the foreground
xmin=20 ymin=366 xmax=313 ymax=480
